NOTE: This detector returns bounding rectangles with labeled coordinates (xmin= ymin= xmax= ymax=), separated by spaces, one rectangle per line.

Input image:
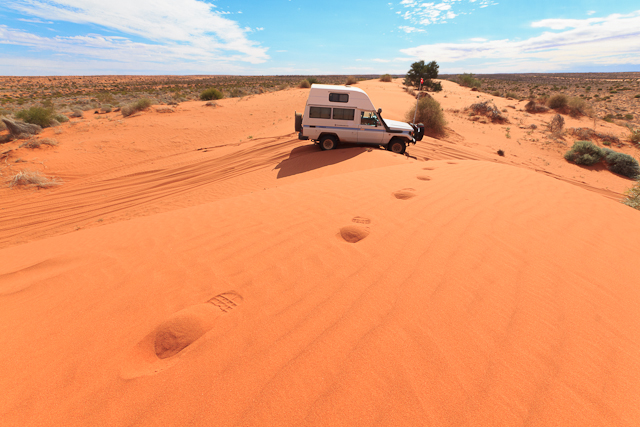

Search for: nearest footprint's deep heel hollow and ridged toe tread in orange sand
xmin=154 ymin=291 xmax=242 ymax=359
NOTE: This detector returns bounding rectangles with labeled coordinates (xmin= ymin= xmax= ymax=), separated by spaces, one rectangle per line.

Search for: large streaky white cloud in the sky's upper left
xmin=0 ymin=0 xmax=269 ymax=64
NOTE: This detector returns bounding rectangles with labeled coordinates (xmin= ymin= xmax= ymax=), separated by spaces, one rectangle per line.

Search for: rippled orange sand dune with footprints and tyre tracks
xmin=0 ymin=79 xmax=640 ymax=427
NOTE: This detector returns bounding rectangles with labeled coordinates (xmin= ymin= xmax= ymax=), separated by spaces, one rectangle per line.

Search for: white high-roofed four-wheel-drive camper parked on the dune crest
xmin=295 ymin=84 xmax=424 ymax=154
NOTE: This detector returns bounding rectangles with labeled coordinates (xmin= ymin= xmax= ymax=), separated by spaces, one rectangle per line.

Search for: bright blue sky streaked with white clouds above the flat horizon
xmin=0 ymin=0 xmax=640 ymax=75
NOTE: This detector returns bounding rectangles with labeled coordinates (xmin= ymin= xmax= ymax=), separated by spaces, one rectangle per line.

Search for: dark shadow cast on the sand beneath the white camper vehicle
xmin=275 ymin=145 xmax=370 ymax=179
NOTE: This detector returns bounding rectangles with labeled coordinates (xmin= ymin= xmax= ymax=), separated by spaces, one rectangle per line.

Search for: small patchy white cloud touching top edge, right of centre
xmin=396 ymin=0 xmax=498 ymax=28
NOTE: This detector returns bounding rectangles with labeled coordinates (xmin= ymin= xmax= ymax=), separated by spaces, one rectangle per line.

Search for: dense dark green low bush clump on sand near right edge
xmin=564 ymin=141 xmax=640 ymax=178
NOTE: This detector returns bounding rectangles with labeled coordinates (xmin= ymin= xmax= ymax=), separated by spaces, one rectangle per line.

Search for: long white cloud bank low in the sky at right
xmin=401 ymin=11 xmax=640 ymax=71
